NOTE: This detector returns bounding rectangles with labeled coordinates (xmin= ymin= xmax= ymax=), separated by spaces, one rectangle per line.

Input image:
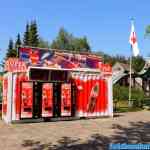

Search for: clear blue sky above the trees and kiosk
xmin=0 ymin=0 xmax=150 ymax=60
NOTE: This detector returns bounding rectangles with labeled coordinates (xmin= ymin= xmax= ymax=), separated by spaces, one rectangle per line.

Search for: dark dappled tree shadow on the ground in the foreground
xmin=22 ymin=122 xmax=150 ymax=150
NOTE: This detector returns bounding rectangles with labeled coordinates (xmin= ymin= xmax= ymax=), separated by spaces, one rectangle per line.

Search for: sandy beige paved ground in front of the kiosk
xmin=0 ymin=111 xmax=150 ymax=150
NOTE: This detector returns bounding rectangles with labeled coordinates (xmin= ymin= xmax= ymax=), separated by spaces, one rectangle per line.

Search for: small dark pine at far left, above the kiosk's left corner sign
xmin=5 ymin=39 xmax=17 ymax=59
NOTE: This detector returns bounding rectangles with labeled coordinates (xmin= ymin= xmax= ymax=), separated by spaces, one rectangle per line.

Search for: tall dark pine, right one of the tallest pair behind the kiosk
xmin=29 ymin=21 xmax=39 ymax=47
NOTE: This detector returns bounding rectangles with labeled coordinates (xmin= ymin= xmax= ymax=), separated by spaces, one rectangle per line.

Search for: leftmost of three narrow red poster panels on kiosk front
xmin=21 ymin=82 xmax=33 ymax=118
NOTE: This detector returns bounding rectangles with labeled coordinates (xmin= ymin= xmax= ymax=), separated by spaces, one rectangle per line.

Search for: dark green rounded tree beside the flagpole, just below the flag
xmin=132 ymin=56 xmax=145 ymax=72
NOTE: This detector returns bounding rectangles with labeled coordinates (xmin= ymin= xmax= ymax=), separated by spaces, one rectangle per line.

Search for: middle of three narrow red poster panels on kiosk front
xmin=42 ymin=83 xmax=53 ymax=117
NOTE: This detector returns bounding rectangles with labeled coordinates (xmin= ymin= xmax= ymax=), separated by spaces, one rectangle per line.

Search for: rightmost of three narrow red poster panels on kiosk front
xmin=61 ymin=83 xmax=71 ymax=116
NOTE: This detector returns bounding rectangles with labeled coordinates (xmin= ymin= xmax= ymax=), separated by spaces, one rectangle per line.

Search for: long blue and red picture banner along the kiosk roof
xmin=19 ymin=47 xmax=101 ymax=69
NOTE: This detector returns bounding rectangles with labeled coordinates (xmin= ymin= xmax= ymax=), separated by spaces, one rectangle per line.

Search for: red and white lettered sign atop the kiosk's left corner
xmin=4 ymin=58 xmax=27 ymax=72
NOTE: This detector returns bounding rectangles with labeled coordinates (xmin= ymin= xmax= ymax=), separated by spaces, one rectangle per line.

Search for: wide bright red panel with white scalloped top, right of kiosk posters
xmin=73 ymin=74 xmax=108 ymax=117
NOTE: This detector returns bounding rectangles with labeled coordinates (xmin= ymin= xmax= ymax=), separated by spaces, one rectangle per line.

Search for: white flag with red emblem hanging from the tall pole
xmin=129 ymin=22 xmax=140 ymax=57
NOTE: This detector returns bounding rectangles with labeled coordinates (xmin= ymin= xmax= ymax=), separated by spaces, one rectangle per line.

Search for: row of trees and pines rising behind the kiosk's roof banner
xmin=6 ymin=21 xmax=91 ymax=58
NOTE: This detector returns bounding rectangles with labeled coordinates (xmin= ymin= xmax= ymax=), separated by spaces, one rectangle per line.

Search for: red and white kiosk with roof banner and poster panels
xmin=2 ymin=47 xmax=113 ymax=123
